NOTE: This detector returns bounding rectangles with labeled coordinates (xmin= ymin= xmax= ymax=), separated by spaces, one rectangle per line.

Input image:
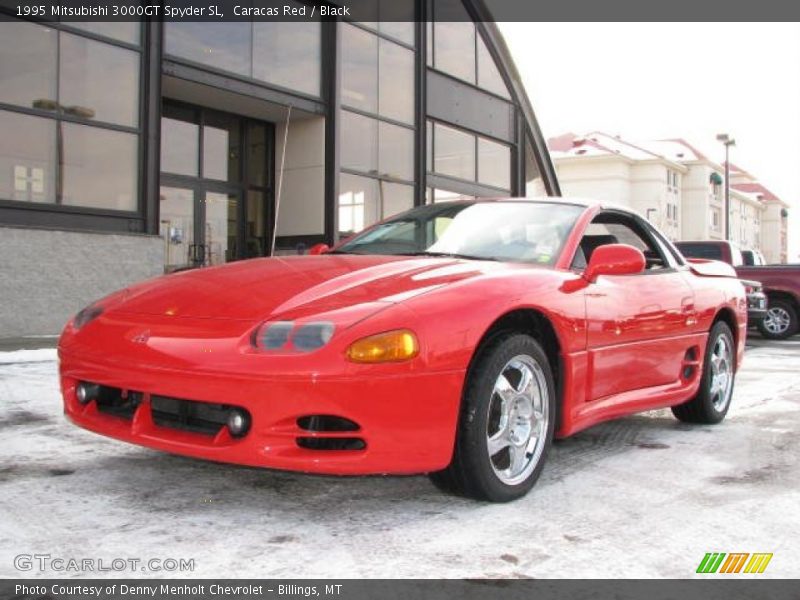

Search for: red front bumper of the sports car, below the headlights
xmin=59 ymin=348 xmax=464 ymax=475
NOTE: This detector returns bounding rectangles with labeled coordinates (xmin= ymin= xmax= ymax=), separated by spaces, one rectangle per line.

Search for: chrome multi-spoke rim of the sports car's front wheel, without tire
xmin=486 ymin=355 xmax=550 ymax=485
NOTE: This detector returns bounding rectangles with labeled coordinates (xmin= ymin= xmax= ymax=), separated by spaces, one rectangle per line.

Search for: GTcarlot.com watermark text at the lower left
xmin=14 ymin=554 xmax=195 ymax=573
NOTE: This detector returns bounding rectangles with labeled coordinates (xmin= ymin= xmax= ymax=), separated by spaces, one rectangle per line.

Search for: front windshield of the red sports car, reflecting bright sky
xmin=333 ymin=201 xmax=583 ymax=265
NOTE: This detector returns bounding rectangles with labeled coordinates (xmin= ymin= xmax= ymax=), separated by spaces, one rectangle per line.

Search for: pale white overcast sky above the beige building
xmin=500 ymin=23 xmax=800 ymax=262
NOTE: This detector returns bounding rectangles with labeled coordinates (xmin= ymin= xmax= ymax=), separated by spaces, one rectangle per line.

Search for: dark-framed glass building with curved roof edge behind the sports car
xmin=0 ymin=0 xmax=559 ymax=337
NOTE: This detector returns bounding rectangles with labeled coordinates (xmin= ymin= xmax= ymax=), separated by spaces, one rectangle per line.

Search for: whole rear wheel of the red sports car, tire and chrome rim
xmin=672 ymin=321 xmax=736 ymax=425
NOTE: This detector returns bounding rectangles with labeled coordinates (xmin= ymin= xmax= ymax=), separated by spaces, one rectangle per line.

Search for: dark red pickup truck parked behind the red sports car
xmin=675 ymin=241 xmax=800 ymax=340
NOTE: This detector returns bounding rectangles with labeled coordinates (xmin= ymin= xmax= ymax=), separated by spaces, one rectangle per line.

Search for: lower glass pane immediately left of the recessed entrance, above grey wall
xmin=61 ymin=123 xmax=138 ymax=211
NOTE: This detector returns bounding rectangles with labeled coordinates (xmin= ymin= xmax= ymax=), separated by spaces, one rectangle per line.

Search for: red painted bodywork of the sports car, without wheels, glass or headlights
xmin=59 ymin=205 xmax=746 ymax=474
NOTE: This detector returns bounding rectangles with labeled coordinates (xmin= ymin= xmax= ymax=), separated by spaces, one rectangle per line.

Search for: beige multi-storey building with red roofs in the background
xmin=549 ymin=132 xmax=788 ymax=263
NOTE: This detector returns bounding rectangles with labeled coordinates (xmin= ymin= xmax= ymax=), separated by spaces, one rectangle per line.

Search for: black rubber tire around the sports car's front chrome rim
xmin=430 ymin=332 xmax=556 ymax=502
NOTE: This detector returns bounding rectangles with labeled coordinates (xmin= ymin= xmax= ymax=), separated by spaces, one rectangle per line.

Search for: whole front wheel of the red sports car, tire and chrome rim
xmin=431 ymin=332 xmax=556 ymax=502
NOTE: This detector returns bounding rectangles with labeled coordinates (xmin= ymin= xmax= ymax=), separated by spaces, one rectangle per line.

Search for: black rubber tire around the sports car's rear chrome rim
xmin=672 ymin=321 xmax=736 ymax=425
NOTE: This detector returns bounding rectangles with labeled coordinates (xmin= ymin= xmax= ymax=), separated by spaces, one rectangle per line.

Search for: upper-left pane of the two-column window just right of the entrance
xmin=341 ymin=23 xmax=378 ymax=113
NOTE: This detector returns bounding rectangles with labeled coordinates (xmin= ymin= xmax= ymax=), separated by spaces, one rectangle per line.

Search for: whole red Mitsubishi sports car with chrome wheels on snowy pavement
xmin=59 ymin=199 xmax=747 ymax=501
